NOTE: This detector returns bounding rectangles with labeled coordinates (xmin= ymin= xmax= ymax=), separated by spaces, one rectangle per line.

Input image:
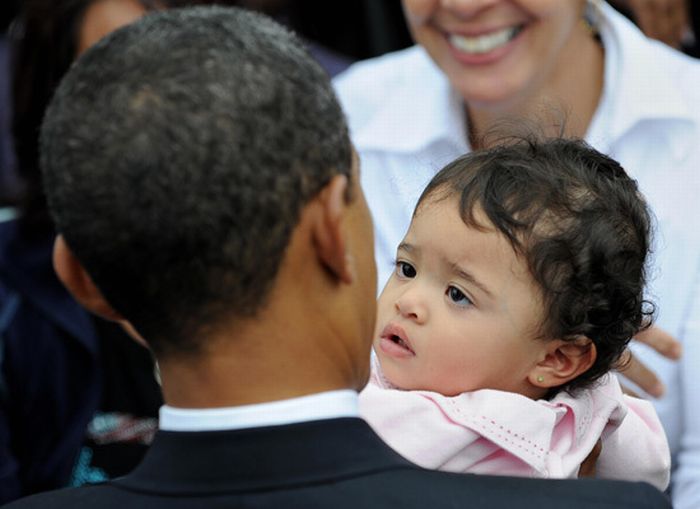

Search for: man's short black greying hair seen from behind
xmin=41 ymin=7 xmax=352 ymax=353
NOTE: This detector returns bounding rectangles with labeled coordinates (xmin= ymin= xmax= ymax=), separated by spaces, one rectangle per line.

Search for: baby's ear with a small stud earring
xmin=528 ymin=337 xmax=597 ymax=389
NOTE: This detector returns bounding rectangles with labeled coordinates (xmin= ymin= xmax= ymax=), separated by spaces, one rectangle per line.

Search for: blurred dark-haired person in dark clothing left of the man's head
xmin=0 ymin=0 xmax=164 ymax=503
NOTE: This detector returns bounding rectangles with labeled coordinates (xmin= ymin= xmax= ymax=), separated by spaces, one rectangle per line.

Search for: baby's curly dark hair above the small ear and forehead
xmin=416 ymin=138 xmax=654 ymax=396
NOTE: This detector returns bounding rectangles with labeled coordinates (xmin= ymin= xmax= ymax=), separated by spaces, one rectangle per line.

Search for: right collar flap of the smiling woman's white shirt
xmin=589 ymin=2 xmax=696 ymax=158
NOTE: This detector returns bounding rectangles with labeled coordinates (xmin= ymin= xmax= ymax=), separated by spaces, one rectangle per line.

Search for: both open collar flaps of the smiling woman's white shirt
xmin=355 ymin=2 xmax=697 ymax=161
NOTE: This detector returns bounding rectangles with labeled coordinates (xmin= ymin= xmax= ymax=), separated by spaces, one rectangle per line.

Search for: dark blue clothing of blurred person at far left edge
xmin=0 ymin=221 xmax=102 ymax=503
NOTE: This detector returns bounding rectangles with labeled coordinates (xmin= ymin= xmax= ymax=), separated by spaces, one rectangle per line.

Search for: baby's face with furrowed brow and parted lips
xmin=374 ymin=198 xmax=546 ymax=395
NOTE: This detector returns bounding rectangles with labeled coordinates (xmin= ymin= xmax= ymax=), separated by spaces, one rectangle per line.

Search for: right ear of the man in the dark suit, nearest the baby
xmin=312 ymin=175 xmax=354 ymax=283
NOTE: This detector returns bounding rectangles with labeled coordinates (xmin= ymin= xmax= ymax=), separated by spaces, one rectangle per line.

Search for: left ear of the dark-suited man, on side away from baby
xmin=53 ymin=235 xmax=124 ymax=322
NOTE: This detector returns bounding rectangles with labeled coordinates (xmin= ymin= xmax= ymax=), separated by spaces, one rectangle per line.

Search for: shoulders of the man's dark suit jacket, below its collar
xmin=6 ymin=466 xmax=671 ymax=509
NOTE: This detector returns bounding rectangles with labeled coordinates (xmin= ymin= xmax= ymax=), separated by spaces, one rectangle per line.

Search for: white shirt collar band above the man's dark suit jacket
xmin=159 ymin=389 xmax=359 ymax=431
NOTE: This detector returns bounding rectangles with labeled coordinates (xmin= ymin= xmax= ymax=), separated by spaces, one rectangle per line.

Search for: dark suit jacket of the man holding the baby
xmin=8 ymin=418 xmax=671 ymax=509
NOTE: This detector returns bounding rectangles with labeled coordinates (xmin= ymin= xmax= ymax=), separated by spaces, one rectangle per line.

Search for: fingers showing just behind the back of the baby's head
xmin=619 ymin=327 xmax=683 ymax=398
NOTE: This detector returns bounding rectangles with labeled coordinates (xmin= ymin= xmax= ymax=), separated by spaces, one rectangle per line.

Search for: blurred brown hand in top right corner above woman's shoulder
xmin=612 ymin=0 xmax=688 ymax=49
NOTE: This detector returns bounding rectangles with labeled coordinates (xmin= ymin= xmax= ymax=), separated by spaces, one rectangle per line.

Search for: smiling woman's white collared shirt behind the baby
xmin=335 ymin=4 xmax=700 ymax=509
